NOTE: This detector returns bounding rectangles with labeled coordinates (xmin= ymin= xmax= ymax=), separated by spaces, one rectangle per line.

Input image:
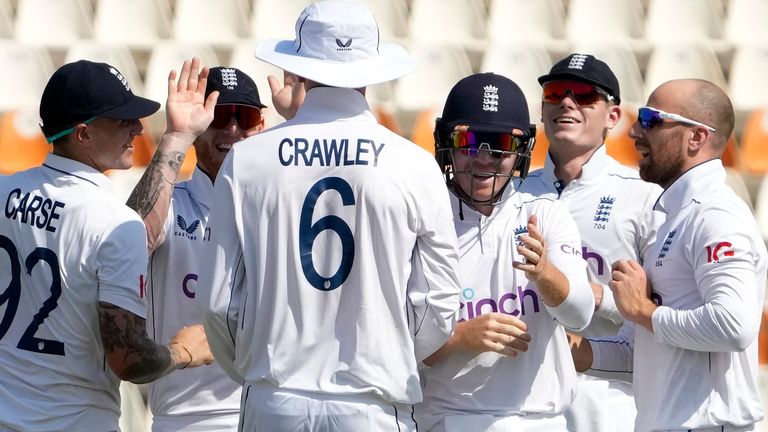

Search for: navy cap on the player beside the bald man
xmin=539 ymin=53 xmax=621 ymax=104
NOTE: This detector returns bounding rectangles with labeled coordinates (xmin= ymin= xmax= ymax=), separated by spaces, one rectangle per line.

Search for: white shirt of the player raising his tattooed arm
xmin=147 ymin=168 xmax=241 ymax=431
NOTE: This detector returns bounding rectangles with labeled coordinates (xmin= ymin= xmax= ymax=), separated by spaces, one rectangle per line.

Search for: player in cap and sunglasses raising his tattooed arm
xmin=128 ymin=67 xmax=266 ymax=432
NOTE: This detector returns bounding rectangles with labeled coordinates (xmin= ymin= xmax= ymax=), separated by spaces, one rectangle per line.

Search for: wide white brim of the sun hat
xmin=256 ymin=39 xmax=416 ymax=88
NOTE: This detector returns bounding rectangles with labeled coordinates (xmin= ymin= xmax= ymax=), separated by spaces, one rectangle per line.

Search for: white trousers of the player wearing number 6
xmin=240 ymin=385 xmax=416 ymax=432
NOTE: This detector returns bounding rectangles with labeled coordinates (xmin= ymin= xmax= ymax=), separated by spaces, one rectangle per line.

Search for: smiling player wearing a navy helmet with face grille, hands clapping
xmin=417 ymin=73 xmax=594 ymax=432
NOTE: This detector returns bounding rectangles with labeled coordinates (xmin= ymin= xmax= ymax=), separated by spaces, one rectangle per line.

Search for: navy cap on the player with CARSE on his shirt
xmin=40 ymin=60 xmax=160 ymax=142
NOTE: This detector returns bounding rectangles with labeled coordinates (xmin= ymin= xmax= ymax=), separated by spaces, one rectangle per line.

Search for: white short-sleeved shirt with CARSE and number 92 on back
xmin=0 ymin=154 xmax=147 ymax=432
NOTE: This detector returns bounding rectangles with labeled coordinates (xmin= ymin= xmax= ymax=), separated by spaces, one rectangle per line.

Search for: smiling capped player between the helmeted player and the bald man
xmin=521 ymin=53 xmax=663 ymax=432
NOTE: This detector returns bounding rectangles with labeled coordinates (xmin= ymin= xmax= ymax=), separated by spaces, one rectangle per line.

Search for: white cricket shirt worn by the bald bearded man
xmin=592 ymin=159 xmax=768 ymax=431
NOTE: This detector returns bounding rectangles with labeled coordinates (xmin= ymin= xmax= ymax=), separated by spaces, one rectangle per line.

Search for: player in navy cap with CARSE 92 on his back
xmin=0 ymin=60 xmax=213 ymax=432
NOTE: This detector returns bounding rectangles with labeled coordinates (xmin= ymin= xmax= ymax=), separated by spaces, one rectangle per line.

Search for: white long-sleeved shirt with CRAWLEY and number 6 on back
xmin=198 ymin=87 xmax=459 ymax=403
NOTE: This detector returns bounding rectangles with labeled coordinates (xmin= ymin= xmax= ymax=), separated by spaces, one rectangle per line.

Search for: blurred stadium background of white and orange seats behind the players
xmin=0 ymin=0 xmax=768 ymax=431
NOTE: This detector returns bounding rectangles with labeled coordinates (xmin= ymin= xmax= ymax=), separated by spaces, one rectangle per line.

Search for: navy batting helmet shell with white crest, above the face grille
xmin=440 ymin=72 xmax=530 ymax=136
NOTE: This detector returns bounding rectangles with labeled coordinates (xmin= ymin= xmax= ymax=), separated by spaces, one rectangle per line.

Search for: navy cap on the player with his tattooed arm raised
xmin=205 ymin=67 xmax=267 ymax=108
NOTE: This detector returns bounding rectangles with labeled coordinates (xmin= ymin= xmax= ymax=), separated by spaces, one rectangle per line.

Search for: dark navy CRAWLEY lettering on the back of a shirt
xmin=277 ymin=138 xmax=385 ymax=167
